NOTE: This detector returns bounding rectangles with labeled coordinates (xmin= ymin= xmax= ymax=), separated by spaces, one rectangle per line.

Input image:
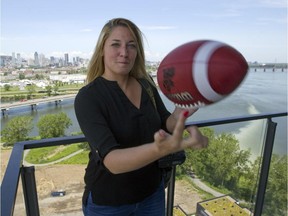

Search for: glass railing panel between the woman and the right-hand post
xmin=174 ymin=119 xmax=267 ymax=215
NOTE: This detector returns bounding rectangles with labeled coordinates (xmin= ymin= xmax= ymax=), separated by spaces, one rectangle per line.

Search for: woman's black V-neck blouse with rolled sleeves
xmin=74 ymin=77 xmax=170 ymax=206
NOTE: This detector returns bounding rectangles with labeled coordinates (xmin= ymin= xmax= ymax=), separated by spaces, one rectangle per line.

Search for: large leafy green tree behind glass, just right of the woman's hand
xmin=186 ymin=128 xmax=250 ymax=189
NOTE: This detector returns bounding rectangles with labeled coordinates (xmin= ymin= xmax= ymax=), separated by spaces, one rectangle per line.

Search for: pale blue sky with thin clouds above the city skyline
xmin=0 ymin=0 xmax=287 ymax=63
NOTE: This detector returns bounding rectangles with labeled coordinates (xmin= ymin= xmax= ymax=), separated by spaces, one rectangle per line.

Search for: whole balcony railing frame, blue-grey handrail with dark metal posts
xmin=1 ymin=112 xmax=287 ymax=216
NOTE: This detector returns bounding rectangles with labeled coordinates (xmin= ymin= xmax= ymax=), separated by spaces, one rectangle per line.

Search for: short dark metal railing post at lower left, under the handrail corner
xmin=21 ymin=166 xmax=40 ymax=216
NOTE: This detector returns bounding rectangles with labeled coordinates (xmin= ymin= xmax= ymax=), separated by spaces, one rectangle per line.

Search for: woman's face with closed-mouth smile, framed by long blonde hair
xmin=103 ymin=26 xmax=137 ymax=77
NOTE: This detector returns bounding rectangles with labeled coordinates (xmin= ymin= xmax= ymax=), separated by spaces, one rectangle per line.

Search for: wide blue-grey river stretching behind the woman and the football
xmin=1 ymin=69 xmax=287 ymax=160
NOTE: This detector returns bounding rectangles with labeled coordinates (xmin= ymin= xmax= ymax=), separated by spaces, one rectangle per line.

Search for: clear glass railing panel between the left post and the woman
xmin=24 ymin=144 xmax=88 ymax=216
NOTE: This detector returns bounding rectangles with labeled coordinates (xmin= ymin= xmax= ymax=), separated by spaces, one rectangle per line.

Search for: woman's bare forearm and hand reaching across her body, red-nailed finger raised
xmin=103 ymin=111 xmax=208 ymax=174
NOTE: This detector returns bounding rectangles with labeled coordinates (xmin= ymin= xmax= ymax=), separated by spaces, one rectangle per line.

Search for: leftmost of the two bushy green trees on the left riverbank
xmin=1 ymin=116 xmax=33 ymax=146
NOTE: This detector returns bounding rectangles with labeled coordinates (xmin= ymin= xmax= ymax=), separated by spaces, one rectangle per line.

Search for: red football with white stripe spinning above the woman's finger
xmin=157 ymin=40 xmax=248 ymax=108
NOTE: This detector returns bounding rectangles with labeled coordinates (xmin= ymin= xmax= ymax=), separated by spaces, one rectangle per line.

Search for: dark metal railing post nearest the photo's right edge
xmin=254 ymin=118 xmax=277 ymax=216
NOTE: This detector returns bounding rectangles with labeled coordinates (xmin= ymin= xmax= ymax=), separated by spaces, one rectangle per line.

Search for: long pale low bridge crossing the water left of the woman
xmin=1 ymin=94 xmax=76 ymax=116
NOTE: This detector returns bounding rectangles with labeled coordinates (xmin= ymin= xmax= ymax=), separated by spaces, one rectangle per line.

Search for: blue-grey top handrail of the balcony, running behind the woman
xmin=1 ymin=112 xmax=287 ymax=216
